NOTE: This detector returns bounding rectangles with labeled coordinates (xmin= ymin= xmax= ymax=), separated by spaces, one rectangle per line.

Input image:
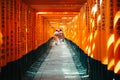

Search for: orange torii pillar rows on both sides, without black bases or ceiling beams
xmin=0 ymin=0 xmax=120 ymax=79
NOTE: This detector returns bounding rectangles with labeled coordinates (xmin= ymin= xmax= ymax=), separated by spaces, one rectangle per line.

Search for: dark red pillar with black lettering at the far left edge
xmin=0 ymin=0 xmax=7 ymax=66
